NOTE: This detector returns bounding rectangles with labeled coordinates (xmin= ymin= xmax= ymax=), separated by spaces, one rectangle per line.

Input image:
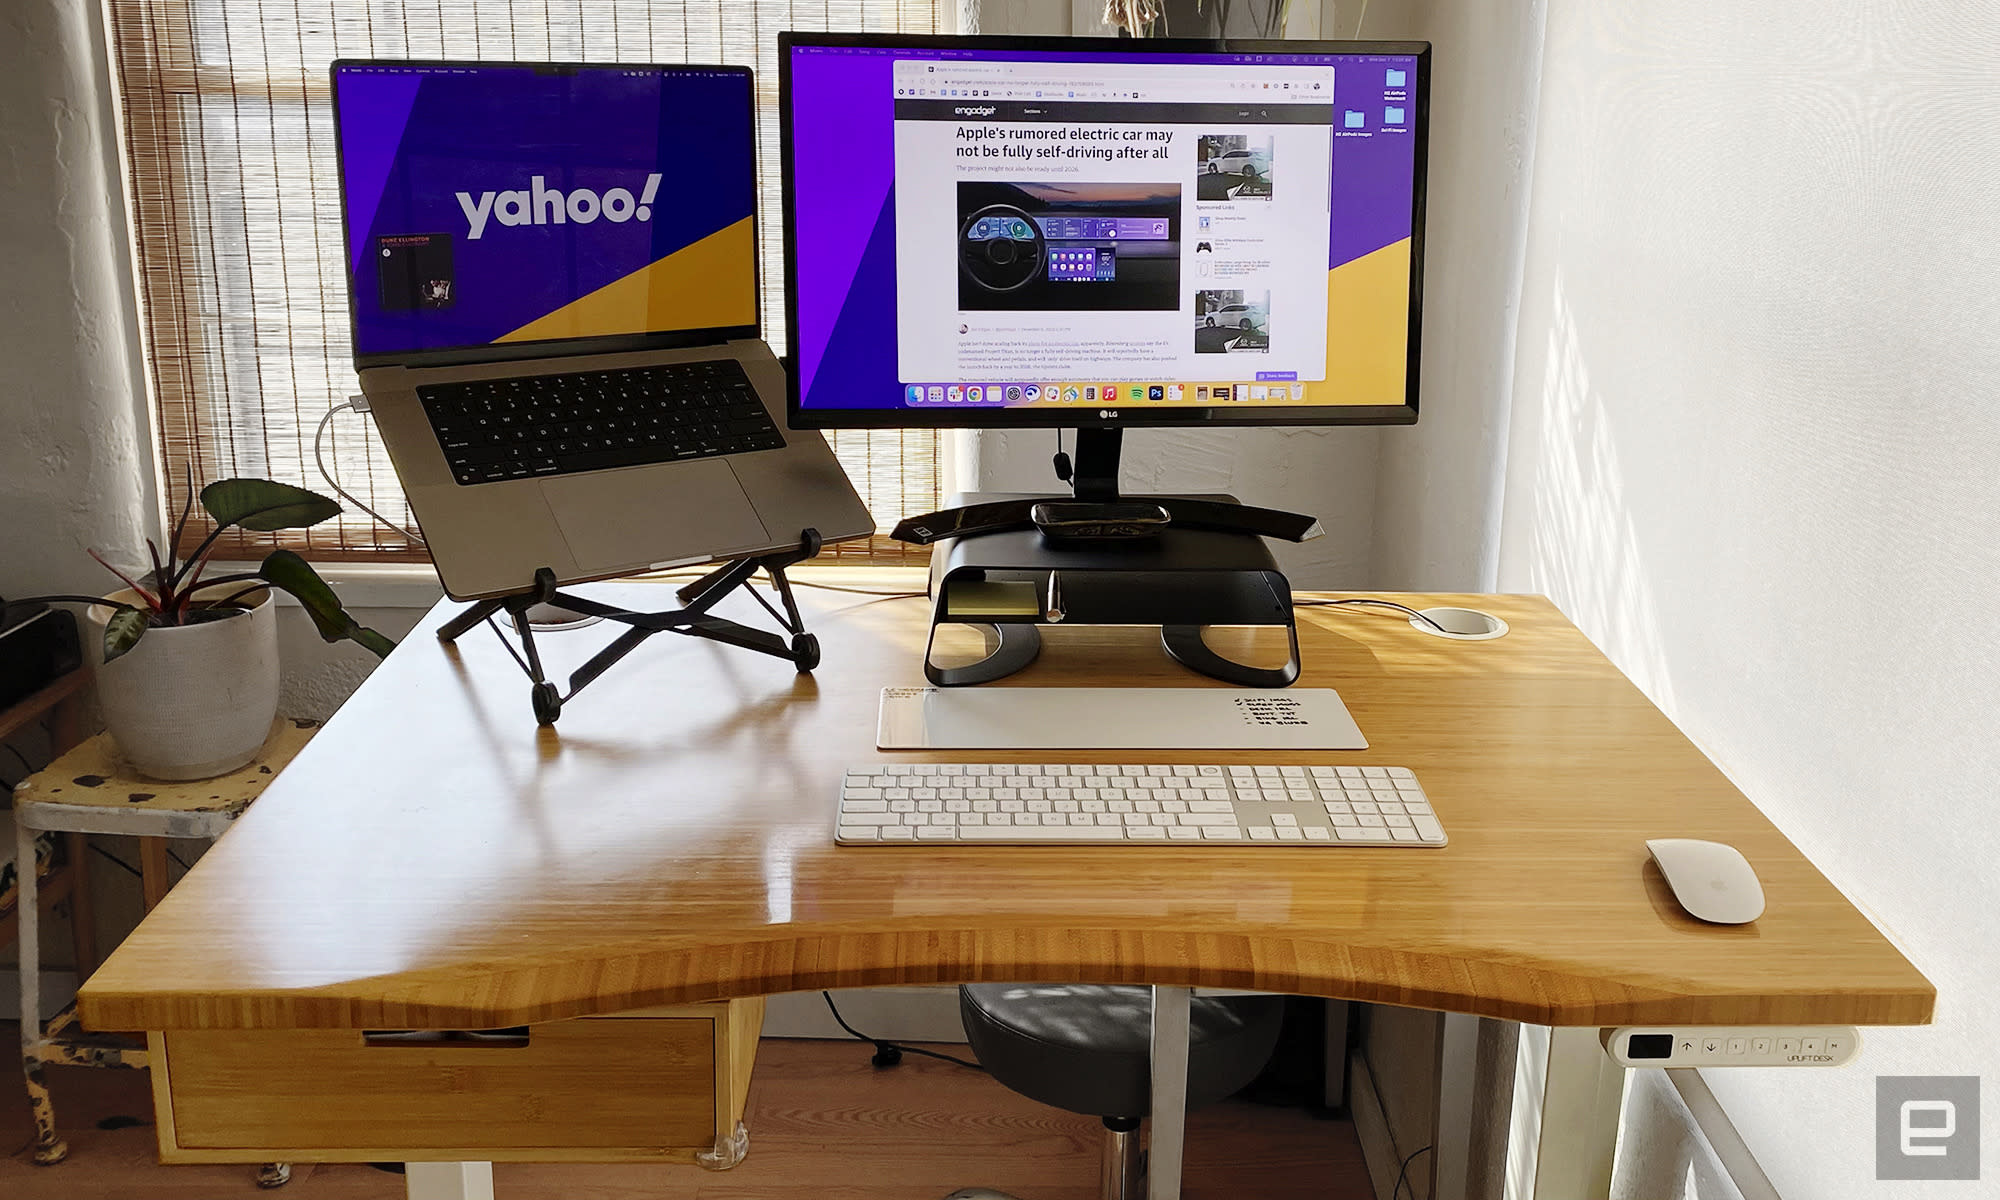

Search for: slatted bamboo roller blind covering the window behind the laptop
xmin=110 ymin=0 xmax=954 ymax=560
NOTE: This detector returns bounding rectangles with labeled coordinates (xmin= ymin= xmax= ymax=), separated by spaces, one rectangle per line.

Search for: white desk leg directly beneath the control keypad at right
xmin=1532 ymin=1026 xmax=1626 ymax=1200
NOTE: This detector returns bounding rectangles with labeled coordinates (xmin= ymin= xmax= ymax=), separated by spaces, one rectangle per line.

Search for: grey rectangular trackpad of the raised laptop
xmin=542 ymin=458 xmax=770 ymax=574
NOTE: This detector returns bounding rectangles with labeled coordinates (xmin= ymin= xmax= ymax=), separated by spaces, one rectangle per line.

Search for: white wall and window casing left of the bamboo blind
xmin=0 ymin=0 xmax=158 ymax=596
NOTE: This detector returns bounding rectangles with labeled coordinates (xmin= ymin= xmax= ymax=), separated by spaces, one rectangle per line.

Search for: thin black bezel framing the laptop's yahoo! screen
xmin=326 ymin=58 xmax=764 ymax=370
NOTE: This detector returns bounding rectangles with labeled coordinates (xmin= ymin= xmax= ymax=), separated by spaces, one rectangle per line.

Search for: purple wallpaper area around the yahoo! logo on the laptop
xmin=334 ymin=66 xmax=756 ymax=354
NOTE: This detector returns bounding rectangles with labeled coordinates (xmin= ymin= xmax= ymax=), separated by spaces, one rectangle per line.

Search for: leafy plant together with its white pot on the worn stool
xmin=7 ymin=478 xmax=394 ymax=780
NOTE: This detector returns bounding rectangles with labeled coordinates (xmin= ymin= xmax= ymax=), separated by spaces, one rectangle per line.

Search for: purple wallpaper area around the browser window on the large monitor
xmin=788 ymin=46 xmax=1418 ymax=410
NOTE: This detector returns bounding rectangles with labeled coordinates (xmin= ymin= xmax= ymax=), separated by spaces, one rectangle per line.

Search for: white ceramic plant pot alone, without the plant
xmin=90 ymin=584 xmax=278 ymax=780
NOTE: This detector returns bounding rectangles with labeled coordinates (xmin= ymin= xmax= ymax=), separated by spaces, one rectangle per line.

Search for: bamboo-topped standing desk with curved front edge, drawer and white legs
xmin=80 ymin=576 xmax=1936 ymax=1200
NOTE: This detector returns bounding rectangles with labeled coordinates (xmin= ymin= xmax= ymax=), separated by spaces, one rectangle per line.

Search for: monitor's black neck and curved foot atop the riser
xmin=890 ymin=426 xmax=1326 ymax=546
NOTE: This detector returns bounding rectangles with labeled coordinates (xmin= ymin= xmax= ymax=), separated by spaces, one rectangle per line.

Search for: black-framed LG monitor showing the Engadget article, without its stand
xmin=780 ymin=34 xmax=1430 ymax=428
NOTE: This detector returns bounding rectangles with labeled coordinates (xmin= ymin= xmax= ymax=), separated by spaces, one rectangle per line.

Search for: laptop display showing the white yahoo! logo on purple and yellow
xmin=334 ymin=62 xmax=758 ymax=362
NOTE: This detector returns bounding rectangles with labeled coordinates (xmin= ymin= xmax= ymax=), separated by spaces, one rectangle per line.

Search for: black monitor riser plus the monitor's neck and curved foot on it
xmin=896 ymin=430 xmax=1320 ymax=688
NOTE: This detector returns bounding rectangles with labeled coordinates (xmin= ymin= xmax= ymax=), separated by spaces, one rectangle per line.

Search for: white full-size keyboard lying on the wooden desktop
xmin=834 ymin=762 xmax=1444 ymax=846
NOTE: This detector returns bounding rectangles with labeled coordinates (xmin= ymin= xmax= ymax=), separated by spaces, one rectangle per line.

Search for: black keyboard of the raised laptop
xmin=416 ymin=358 xmax=784 ymax=484
